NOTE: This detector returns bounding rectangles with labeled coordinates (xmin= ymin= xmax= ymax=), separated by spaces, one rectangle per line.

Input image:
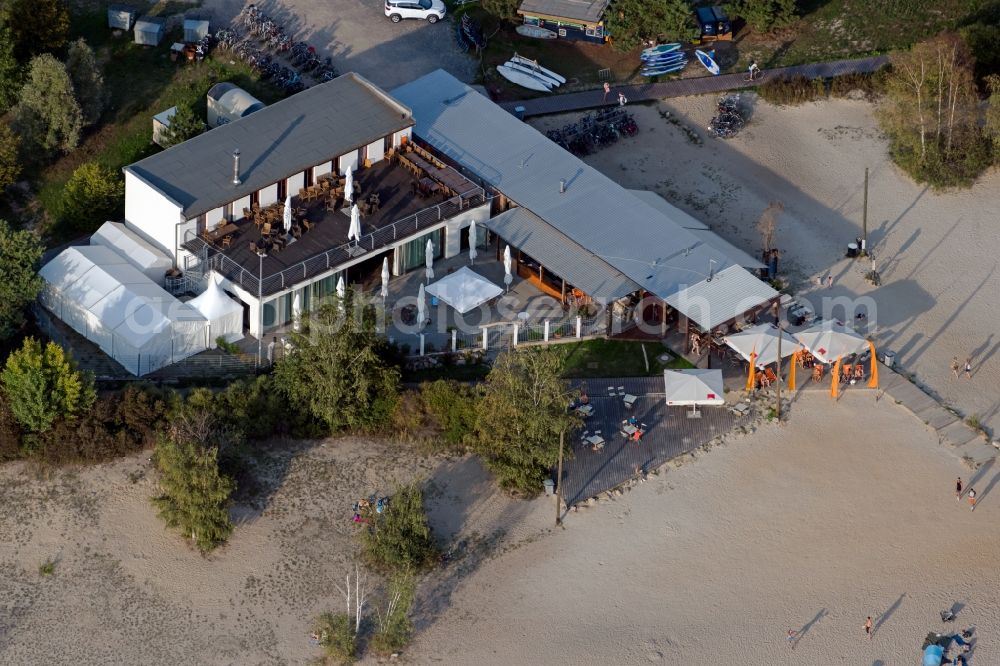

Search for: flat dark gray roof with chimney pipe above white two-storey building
xmin=125 ymin=73 xmax=413 ymax=219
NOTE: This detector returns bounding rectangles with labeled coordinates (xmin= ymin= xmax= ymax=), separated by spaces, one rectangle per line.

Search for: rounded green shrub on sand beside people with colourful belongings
xmin=359 ymin=483 xmax=438 ymax=570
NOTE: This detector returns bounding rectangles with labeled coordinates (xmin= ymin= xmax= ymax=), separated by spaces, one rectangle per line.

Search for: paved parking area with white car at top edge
xmin=202 ymin=0 xmax=478 ymax=90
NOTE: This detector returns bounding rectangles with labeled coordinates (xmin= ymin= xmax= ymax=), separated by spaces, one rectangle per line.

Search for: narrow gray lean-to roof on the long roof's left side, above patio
xmin=485 ymin=208 xmax=640 ymax=302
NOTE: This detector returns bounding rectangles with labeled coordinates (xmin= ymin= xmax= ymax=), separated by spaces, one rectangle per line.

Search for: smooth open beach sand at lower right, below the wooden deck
xmin=411 ymin=393 xmax=1000 ymax=665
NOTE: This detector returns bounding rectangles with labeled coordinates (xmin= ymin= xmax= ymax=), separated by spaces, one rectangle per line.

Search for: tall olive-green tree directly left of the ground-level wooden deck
xmin=476 ymin=349 xmax=579 ymax=496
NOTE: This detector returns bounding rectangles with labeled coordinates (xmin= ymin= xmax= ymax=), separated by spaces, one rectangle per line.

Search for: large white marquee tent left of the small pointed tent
xmin=39 ymin=245 xmax=208 ymax=375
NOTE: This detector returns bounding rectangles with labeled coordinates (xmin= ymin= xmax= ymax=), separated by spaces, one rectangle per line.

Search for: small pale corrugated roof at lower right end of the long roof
xmin=664 ymin=266 xmax=778 ymax=331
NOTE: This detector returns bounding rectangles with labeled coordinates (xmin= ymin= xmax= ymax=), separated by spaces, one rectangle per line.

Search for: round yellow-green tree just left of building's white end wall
xmin=59 ymin=162 xmax=125 ymax=231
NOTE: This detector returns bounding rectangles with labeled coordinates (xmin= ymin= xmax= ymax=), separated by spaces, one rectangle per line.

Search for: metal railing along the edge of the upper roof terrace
xmin=191 ymin=186 xmax=492 ymax=296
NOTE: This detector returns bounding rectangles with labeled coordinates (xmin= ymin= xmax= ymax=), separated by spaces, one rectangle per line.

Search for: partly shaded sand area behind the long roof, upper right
xmin=534 ymin=96 xmax=1000 ymax=431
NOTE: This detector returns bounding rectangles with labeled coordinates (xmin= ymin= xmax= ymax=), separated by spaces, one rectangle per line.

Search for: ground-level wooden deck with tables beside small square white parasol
xmin=563 ymin=376 xmax=750 ymax=506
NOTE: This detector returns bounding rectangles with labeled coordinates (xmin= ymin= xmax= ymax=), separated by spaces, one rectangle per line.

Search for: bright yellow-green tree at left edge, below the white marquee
xmin=0 ymin=337 xmax=97 ymax=432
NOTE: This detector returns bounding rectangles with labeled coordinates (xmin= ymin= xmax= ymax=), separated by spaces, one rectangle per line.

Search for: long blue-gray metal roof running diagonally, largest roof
xmin=393 ymin=69 xmax=756 ymax=298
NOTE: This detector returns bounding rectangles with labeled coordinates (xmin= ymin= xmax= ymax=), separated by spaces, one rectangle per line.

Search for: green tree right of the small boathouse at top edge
xmin=604 ymin=0 xmax=698 ymax=51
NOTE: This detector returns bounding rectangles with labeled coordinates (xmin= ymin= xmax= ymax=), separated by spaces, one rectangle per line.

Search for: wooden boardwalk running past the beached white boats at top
xmin=500 ymin=56 xmax=889 ymax=117
